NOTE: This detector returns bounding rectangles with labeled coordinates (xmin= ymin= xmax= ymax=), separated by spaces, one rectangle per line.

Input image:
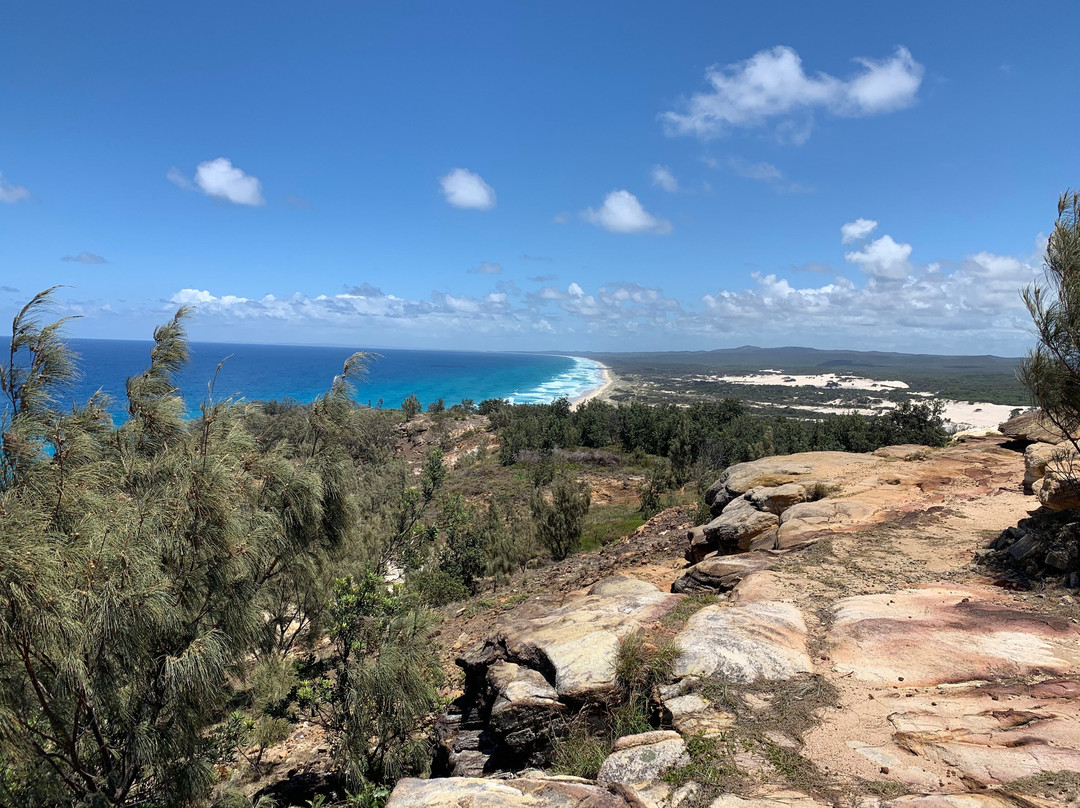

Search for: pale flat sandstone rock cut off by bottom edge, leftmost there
xmin=386 ymin=777 xmax=630 ymax=808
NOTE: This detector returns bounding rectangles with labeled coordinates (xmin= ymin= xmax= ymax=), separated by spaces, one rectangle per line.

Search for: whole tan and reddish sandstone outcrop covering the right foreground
xmin=399 ymin=439 xmax=1080 ymax=808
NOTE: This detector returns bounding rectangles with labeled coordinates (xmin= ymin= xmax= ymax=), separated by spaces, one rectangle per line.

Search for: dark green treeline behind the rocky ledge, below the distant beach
xmin=480 ymin=399 xmax=948 ymax=477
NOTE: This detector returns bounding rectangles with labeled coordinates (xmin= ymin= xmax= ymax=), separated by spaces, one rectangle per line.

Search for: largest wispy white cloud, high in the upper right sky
xmin=661 ymin=45 xmax=923 ymax=143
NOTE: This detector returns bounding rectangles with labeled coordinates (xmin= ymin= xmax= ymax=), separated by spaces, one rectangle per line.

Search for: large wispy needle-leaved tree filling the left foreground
xmin=0 ymin=291 xmax=362 ymax=806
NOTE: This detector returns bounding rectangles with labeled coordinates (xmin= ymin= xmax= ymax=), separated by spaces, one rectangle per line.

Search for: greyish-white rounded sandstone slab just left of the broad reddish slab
xmin=675 ymin=602 xmax=813 ymax=684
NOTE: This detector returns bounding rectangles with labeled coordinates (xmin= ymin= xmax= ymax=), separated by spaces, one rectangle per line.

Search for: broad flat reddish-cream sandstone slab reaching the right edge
xmin=829 ymin=587 xmax=1080 ymax=687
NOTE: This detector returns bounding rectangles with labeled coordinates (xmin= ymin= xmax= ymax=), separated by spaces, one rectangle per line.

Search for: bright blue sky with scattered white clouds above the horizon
xmin=0 ymin=0 xmax=1080 ymax=354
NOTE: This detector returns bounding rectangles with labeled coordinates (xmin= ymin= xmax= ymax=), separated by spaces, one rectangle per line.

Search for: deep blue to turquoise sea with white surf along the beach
xmin=52 ymin=339 xmax=603 ymax=418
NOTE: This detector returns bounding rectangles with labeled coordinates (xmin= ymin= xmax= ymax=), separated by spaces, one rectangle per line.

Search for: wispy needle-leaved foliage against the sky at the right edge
xmin=1020 ymin=192 xmax=1080 ymax=449
